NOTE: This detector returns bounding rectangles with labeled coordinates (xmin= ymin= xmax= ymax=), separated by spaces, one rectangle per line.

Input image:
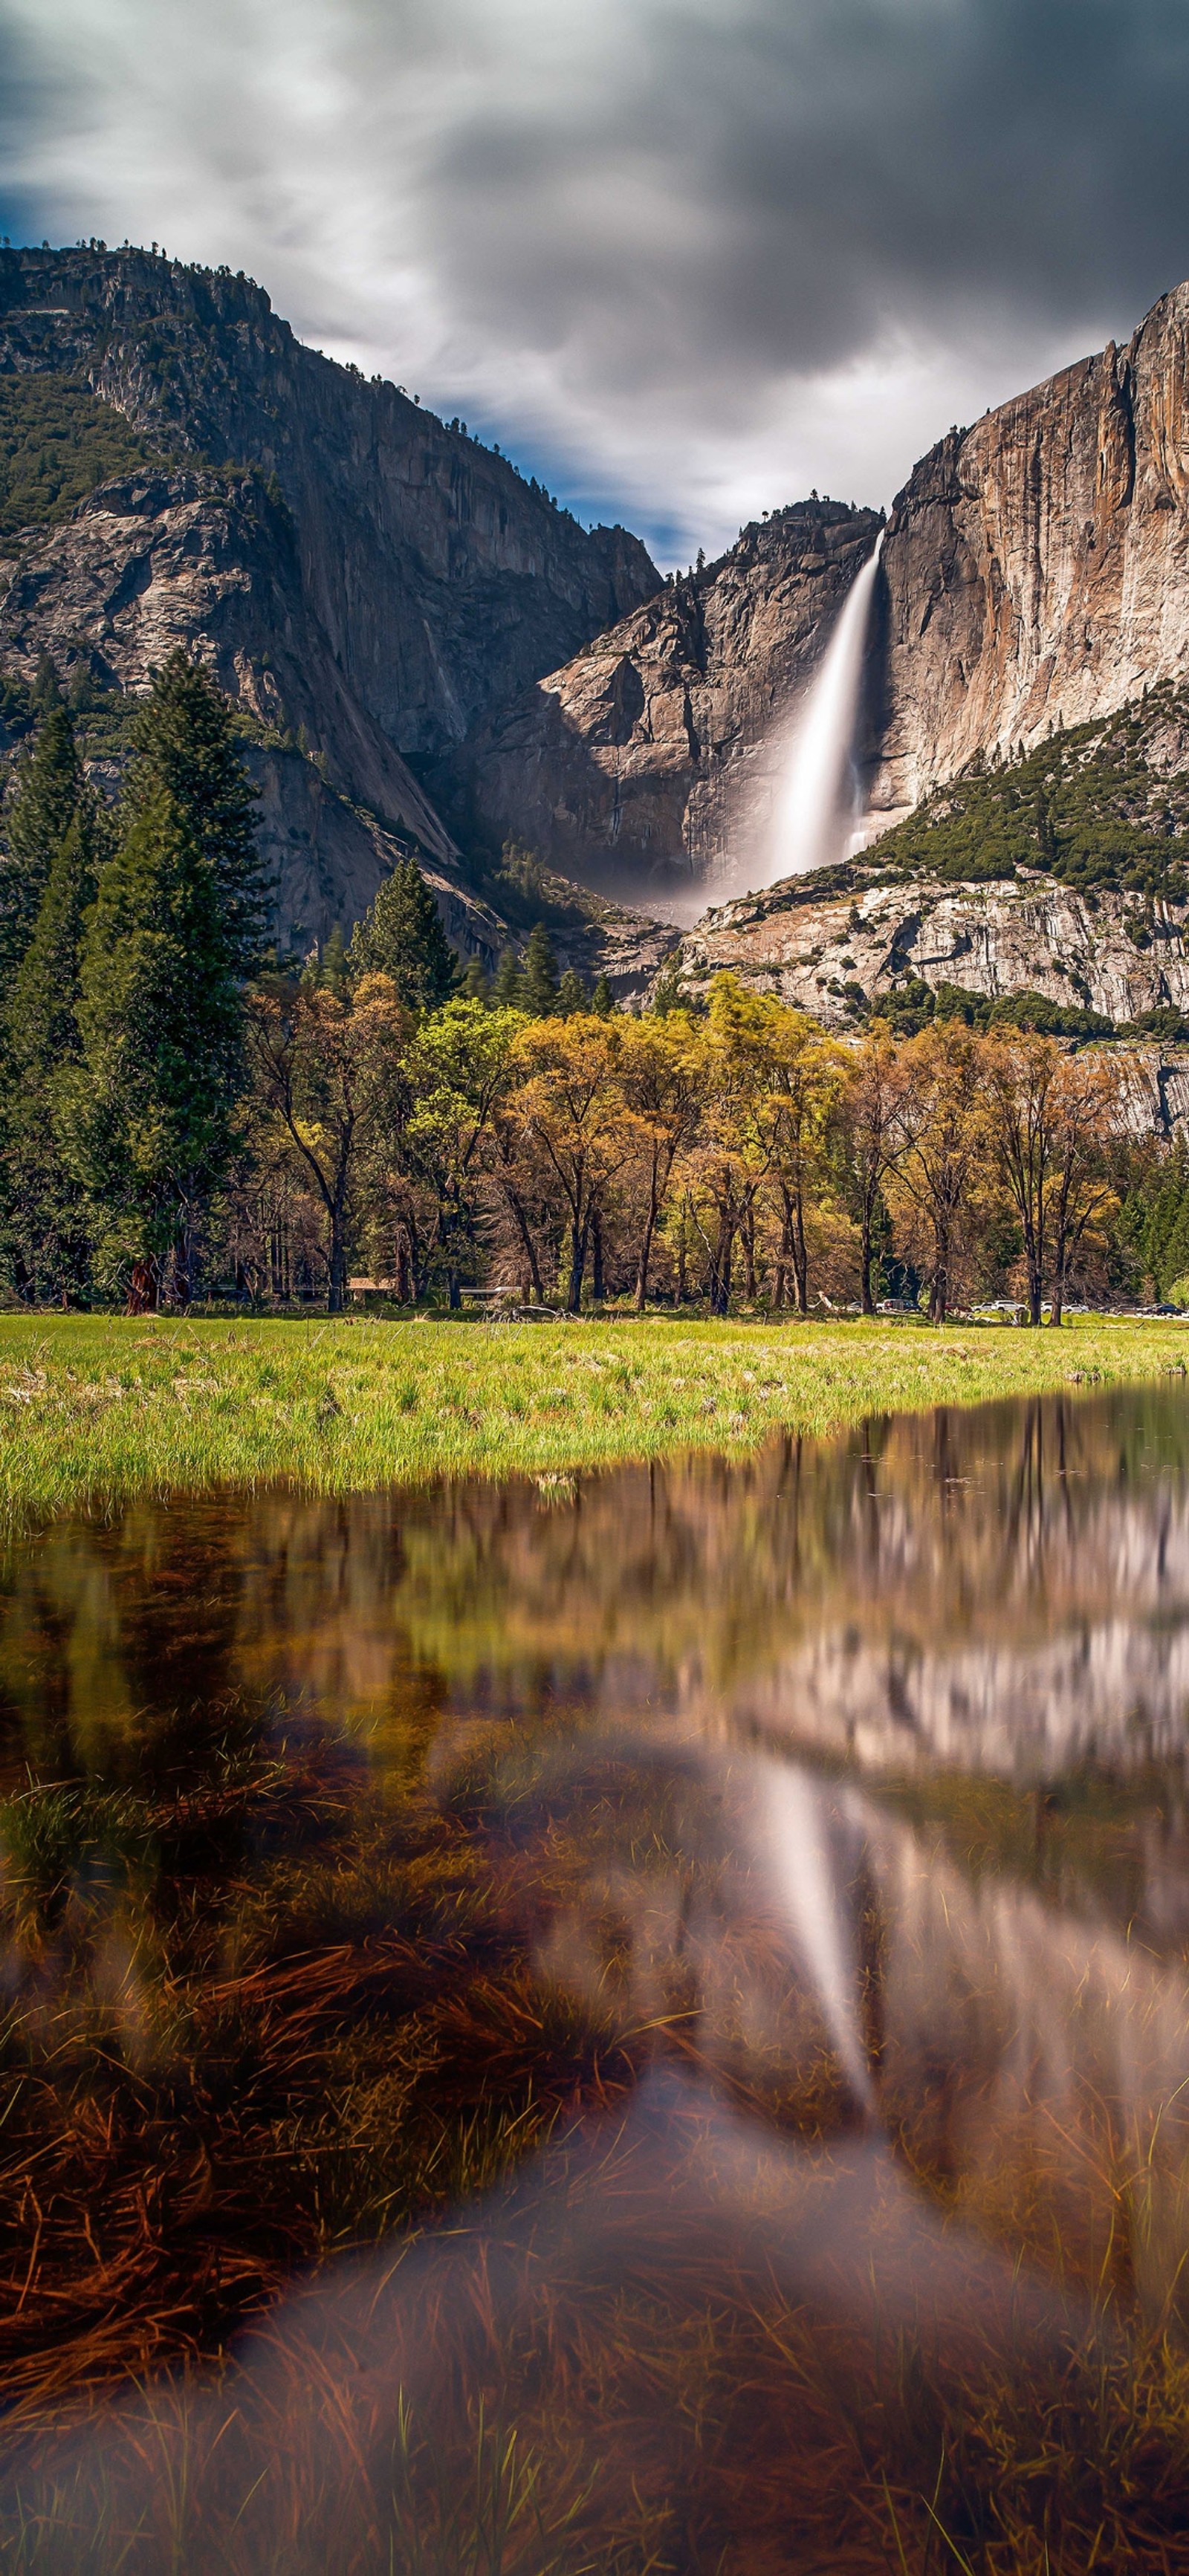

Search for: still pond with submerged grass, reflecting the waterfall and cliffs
xmin=0 ymin=1386 xmax=1189 ymax=2576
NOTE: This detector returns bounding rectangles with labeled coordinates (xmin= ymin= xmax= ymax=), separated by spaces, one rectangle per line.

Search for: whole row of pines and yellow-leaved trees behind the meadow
xmin=0 ymin=655 xmax=1189 ymax=1324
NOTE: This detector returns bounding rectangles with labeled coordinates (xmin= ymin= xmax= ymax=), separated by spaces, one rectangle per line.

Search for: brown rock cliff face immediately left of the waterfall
xmin=472 ymin=502 xmax=880 ymax=901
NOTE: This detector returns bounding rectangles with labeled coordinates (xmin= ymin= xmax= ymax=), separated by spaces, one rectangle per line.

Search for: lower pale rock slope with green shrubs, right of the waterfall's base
xmin=678 ymin=683 xmax=1189 ymax=1077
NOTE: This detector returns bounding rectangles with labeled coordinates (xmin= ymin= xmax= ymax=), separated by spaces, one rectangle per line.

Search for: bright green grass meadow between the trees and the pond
xmin=0 ymin=1317 xmax=1189 ymax=1515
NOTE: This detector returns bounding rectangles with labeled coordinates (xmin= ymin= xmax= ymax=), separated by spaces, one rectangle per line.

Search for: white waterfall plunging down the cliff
xmin=753 ymin=533 xmax=882 ymax=886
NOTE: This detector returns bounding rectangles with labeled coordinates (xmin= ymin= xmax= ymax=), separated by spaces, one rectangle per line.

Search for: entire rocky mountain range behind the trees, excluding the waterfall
xmin=11 ymin=247 xmax=1189 ymax=1025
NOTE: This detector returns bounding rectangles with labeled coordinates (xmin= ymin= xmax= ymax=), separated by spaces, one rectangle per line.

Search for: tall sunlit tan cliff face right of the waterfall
xmin=869 ymin=286 xmax=1189 ymax=811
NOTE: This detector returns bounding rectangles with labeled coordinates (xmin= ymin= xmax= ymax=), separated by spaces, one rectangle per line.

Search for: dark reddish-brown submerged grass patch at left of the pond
xmin=0 ymin=1747 xmax=632 ymax=2421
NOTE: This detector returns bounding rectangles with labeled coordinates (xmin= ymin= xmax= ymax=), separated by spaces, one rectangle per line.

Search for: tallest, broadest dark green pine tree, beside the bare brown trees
xmin=65 ymin=655 xmax=263 ymax=1303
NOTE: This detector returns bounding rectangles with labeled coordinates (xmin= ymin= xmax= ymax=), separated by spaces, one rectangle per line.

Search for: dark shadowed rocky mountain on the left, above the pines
xmin=0 ymin=247 xmax=661 ymax=948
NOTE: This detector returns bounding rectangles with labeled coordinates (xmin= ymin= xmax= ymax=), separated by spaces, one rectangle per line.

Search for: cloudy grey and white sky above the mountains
xmin=0 ymin=0 xmax=1189 ymax=567
